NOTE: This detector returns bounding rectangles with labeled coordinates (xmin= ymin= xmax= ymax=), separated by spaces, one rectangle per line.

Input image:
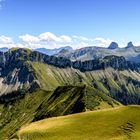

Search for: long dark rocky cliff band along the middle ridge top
xmin=0 ymin=49 xmax=140 ymax=74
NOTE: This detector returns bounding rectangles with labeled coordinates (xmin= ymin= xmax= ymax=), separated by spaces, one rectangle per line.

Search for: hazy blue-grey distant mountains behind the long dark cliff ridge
xmin=0 ymin=42 xmax=140 ymax=62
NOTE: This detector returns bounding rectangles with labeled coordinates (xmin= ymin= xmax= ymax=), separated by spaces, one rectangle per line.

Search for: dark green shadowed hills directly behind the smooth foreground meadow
xmin=0 ymin=85 xmax=121 ymax=140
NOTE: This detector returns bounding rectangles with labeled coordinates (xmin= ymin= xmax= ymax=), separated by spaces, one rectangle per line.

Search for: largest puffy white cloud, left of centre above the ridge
xmin=19 ymin=32 xmax=72 ymax=49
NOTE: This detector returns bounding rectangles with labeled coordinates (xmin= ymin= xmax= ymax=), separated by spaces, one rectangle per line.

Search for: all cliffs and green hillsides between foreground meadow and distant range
xmin=0 ymin=48 xmax=140 ymax=140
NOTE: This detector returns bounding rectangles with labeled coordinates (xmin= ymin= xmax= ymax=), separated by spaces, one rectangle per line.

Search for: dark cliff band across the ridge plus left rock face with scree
xmin=0 ymin=49 xmax=140 ymax=94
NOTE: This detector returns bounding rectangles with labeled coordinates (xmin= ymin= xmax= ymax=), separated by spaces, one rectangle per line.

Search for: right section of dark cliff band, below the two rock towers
xmin=72 ymin=56 xmax=140 ymax=71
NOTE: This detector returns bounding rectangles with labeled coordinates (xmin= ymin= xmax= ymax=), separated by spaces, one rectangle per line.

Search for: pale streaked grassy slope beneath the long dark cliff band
xmin=29 ymin=62 xmax=140 ymax=105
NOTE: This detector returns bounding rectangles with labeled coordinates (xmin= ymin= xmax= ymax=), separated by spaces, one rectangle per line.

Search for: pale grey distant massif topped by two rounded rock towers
xmin=55 ymin=42 xmax=140 ymax=62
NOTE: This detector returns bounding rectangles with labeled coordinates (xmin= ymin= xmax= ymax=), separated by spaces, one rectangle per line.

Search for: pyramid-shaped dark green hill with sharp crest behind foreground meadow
xmin=35 ymin=85 xmax=121 ymax=120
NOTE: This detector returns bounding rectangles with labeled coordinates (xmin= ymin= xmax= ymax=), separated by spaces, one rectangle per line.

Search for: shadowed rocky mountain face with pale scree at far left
xmin=0 ymin=49 xmax=39 ymax=94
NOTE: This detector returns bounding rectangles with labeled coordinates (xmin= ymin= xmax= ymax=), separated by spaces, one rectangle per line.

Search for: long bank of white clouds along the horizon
xmin=0 ymin=32 xmax=115 ymax=49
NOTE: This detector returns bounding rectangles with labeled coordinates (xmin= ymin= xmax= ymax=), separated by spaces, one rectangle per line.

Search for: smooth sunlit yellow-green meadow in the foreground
xmin=18 ymin=106 xmax=140 ymax=140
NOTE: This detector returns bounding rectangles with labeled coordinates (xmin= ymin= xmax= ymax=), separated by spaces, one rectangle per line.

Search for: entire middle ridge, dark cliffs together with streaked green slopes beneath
xmin=0 ymin=49 xmax=140 ymax=104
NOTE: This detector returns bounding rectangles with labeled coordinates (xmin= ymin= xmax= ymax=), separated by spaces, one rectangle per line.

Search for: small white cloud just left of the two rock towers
xmin=94 ymin=37 xmax=113 ymax=47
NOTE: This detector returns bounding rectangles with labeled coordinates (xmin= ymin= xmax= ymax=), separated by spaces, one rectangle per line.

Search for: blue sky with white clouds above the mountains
xmin=0 ymin=0 xmax=140 ymax=48
